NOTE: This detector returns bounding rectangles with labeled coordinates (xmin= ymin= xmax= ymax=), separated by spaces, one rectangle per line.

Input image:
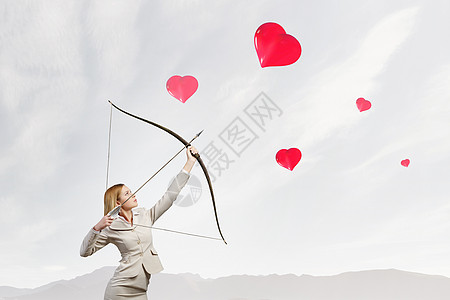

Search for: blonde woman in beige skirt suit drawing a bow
xmin=80 ymin=146 xmax=198 ymax=300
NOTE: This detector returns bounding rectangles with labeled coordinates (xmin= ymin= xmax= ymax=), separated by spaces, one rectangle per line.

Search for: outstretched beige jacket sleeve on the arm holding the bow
xmin=147 ymin=172 xmax=190 ymax=224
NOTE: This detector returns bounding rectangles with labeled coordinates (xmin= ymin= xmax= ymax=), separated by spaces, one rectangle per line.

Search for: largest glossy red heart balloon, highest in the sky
xmin=255 ymin=23 xmax=302 ymax=68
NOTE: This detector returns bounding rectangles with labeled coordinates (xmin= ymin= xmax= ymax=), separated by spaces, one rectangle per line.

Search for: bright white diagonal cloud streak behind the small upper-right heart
xmin=285 ymin=7 xmax=419 ymax=146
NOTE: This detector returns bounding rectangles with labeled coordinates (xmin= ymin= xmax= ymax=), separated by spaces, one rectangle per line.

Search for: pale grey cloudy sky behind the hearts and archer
xmin=0 ymin=0 xmax=450 ymax=288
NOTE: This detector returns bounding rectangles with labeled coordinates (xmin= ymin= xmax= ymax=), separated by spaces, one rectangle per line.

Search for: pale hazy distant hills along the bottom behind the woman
xmin=0 ymin=267 xmax=450 ymax=300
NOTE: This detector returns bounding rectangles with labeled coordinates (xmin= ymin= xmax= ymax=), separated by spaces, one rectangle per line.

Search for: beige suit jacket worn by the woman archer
xmin=80 ymin=172 xmax=189 ymax=277
